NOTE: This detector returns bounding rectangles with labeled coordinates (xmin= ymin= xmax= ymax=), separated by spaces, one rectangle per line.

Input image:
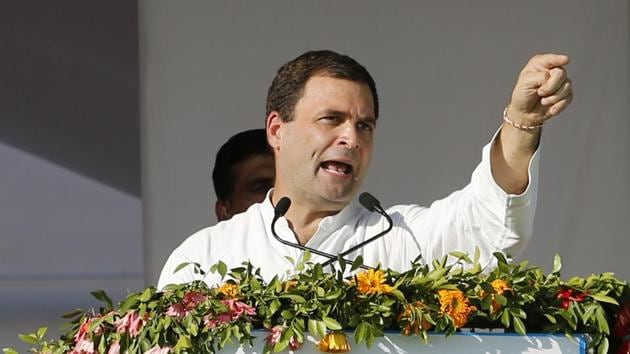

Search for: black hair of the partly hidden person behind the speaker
xmin=212 ymin=129 xmax=273 ymax=200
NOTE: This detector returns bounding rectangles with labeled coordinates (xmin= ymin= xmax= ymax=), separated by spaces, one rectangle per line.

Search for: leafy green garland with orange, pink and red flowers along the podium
xmin=4 ymin=252 xmax=630 ymax=354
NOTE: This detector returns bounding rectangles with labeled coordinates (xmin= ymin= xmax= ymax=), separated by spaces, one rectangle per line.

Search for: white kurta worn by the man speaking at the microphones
xmin=158 ymin=137 xmax=538 ymax=288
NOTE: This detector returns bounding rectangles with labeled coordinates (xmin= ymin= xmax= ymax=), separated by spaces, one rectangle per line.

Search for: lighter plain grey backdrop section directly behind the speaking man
xmin=140 ymin=0 xmax=630 ymax=283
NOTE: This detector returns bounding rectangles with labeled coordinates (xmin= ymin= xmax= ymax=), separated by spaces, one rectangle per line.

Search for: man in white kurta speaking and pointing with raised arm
xmin=158 ymin=51 xmax=572 ymax=288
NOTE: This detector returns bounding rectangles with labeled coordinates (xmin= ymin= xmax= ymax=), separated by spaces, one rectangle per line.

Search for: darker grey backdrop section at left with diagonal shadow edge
xmin=0 ymin=0 xmax=144 ymax=348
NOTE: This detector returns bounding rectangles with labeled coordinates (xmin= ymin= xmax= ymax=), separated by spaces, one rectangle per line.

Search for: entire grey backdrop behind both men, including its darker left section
xmin=0 ymin=0 xmax=630 ymax=346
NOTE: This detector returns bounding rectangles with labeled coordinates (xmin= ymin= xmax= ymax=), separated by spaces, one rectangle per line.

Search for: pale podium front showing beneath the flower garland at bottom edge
xmin=218 ymin=330 xmax=587 ymax=354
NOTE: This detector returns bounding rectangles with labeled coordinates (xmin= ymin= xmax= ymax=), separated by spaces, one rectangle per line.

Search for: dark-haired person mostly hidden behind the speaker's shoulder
xmin=212 ymin=129 xmax=274 ymax=221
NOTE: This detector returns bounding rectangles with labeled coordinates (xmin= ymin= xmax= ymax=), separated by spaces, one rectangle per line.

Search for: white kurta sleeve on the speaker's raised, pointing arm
xmin=405 ymin=133 xmax=539 ymax=266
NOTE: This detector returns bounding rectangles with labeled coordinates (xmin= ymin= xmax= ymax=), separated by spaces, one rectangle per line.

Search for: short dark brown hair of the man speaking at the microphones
xmin=266 ymin=50 xmax=378 ymax=122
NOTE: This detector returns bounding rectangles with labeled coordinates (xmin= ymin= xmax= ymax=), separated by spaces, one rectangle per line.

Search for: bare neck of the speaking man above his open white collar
xmin=271 ymin=190 xmax=341 ymax=245
